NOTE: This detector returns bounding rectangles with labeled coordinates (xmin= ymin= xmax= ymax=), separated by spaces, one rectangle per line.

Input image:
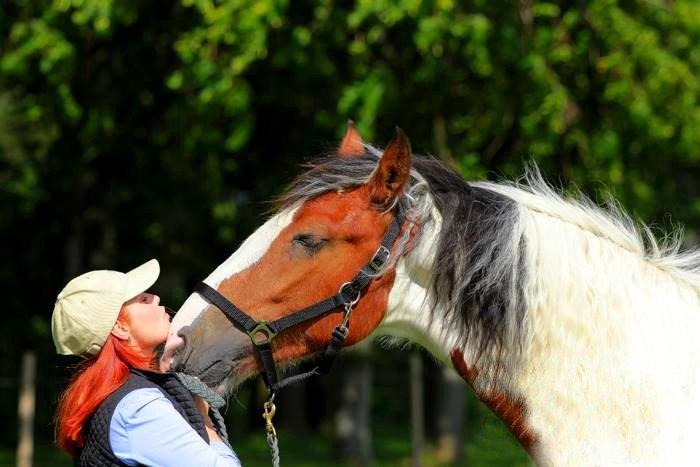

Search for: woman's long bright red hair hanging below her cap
xmin=56 ymin=311 xmax=155 ymax=455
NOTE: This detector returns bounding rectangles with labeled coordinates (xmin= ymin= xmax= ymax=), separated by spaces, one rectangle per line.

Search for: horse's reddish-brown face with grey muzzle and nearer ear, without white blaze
xmin=167 ymin=128 xmax=410 ymax=387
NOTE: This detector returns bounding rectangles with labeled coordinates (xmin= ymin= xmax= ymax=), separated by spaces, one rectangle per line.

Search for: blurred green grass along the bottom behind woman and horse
xmin=0 ymin=400 xmax=532 ymax=467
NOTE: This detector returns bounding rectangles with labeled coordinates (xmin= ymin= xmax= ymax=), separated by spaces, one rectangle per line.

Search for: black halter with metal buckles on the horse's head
xmin=194 ymin=212 xmax=404 ymax=399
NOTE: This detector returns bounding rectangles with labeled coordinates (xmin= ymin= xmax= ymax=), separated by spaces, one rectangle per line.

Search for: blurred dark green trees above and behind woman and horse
xmin=0 ymin=0 xmax=700 ymax=466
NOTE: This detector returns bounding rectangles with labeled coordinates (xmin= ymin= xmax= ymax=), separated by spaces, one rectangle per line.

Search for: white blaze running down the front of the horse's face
xmin=160 ymin=209 xmax=296 ymax=371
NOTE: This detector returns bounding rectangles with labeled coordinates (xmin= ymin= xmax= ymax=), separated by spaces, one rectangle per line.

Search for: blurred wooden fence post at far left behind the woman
xmin=17 ymin=351 xmax=36 ymax=467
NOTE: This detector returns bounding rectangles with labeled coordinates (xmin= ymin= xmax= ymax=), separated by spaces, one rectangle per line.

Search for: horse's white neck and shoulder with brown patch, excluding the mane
xmin=380 ymin=203 xmax=700 ymax=465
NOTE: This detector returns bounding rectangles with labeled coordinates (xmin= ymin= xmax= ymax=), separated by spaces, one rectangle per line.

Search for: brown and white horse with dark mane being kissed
xmin=162 ymin=125 xmax=700 ymax=466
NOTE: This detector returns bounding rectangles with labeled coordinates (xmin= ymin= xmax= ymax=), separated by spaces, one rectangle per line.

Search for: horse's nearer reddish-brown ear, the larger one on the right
xmin=367 ymin=127 xmax=411 ymax=207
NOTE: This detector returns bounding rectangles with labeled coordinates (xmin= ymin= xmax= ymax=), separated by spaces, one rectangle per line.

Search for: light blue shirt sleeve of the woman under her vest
xmin=109 ymin=388 xmax=241 ymax=467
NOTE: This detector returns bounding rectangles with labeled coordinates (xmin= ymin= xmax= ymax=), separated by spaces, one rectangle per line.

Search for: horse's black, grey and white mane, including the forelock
xmin=280 ymin=149 xmax=700 ymax=383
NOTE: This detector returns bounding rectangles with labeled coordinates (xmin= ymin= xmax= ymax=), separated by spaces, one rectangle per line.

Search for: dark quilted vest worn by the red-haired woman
xmin=75 ymin=370 xmax=209 ymax=467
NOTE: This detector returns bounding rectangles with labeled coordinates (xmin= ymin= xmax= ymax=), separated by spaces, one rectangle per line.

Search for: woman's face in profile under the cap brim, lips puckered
xmin=119 ymin=292 xmax=170 ymax=353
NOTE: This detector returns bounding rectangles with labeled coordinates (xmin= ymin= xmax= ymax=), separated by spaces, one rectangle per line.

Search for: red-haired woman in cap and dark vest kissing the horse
xmin=51 ymin=260 xmax=240 ymax=467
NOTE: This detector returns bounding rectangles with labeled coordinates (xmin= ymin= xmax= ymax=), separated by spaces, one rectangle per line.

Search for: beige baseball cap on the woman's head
xmin=51 ymin=259 xmax=160 ymax=356
